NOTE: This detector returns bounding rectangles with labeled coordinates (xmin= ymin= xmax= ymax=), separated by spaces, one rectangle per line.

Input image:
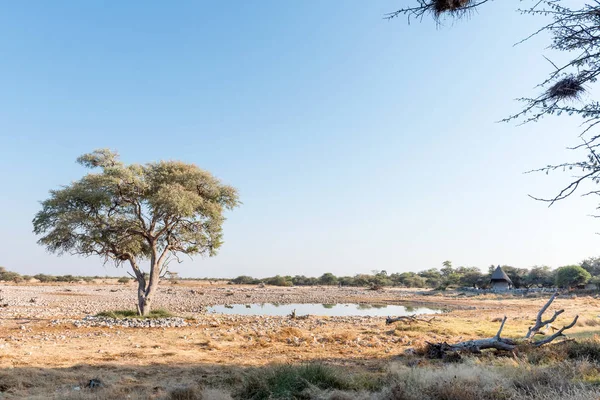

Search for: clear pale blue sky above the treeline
xmin=0 ymin=0 xmax=600 ymax=277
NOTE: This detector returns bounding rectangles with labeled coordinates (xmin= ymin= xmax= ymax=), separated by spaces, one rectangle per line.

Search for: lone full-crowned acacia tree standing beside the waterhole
xmin=33 ymin=149 xmax=239 ymax=315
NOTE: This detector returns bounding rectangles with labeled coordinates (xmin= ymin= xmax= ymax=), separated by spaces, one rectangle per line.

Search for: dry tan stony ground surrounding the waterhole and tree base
xmin=0 ymin=282 xmax=600 ymax=398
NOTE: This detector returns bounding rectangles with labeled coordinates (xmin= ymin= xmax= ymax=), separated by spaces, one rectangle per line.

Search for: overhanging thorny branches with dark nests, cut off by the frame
xmin=386 ymin=0 xmax=600 ymax=208
